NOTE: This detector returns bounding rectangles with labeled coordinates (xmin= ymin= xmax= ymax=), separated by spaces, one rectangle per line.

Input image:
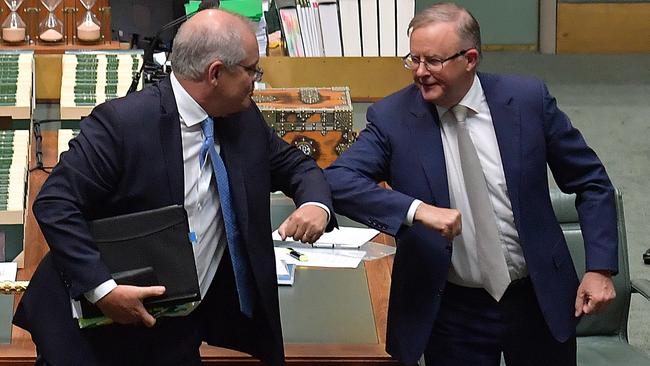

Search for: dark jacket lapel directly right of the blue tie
xmin=214 ymin=117 xmax=248 ymax=243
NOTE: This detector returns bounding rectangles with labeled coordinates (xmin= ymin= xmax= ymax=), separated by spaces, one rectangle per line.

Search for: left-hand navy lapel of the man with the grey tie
xmin=406 ymin=89 xmax=449 ymax=207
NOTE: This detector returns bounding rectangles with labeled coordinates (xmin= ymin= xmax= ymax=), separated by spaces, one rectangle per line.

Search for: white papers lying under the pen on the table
xmin=274 ymin=247 xmax=366 ymax=268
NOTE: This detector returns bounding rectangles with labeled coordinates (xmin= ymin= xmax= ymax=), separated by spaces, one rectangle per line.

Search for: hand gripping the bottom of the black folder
xmin=96 ymin=285 xmax=165 ymax=328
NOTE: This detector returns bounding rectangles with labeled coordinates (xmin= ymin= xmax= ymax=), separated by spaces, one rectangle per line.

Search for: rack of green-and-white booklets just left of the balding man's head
xmin=61 ymin=50 xmax=143 ymax=120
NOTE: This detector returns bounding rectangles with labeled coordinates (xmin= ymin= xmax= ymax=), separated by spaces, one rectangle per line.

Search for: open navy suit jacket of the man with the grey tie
xmin=325 ymin=73 xmax=618 ymax=364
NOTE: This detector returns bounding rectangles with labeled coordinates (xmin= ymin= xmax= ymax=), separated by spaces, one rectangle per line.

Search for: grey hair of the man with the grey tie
xmin=407 ymin=3 xmax=483 ymax=56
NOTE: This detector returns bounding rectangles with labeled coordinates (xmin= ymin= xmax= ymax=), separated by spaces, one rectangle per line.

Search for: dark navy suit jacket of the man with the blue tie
xmin=14 ymin=79 xmax=335 ymax=364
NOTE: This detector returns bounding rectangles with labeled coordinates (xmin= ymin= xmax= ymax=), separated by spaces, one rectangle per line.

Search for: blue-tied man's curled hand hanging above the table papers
xmin=278 ymin=205 xmax=327 ymax=243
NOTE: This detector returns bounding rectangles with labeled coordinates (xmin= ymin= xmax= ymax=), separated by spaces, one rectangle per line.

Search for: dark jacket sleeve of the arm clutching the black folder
xmin=33 ymin=103 xmax=122 ymax=299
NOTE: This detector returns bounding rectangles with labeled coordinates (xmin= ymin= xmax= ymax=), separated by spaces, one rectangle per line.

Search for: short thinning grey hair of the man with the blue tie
xmin=170 ymin=11 xmax=252 ymax=81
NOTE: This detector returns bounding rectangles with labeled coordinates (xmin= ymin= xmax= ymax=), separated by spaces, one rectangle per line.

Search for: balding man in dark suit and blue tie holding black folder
xmin=14 ymin=10 xmax=335 ymax=365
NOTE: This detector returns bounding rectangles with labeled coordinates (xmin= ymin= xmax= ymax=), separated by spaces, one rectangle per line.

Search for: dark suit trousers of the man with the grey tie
xmin=424 ymin=277 xmax=576 ymax=366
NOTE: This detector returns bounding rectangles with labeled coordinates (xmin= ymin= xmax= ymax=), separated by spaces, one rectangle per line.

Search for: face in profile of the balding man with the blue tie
xmin=218 ymin=37 xmax=259 ymax=115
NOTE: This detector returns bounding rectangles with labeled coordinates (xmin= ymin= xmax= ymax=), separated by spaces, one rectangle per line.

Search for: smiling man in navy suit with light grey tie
xmin=325 ymin=3 xmax=618 ymax=366
